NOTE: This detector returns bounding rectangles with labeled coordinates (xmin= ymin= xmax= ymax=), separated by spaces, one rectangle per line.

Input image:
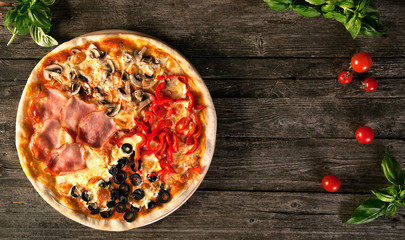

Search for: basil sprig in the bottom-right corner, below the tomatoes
xmin=343 ymin=148 xmax=405 ymax=224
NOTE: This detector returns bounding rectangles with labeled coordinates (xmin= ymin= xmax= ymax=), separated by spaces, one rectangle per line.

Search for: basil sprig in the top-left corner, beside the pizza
xmin=4 ymin=0 xmax=58 ymax=47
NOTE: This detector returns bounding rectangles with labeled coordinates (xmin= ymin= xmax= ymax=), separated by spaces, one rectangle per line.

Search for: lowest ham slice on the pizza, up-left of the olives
xmin=46 ymin=143 xmax=86 ymax=175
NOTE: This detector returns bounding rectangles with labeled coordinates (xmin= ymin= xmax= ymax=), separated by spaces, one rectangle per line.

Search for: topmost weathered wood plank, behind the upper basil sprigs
xmin=0 ymin=0 xmax=405 ymax=58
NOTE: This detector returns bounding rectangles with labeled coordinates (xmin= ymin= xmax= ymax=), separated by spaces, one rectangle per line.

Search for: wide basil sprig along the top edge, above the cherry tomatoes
xmin=264 ymin=0 xmax=387 ymax=39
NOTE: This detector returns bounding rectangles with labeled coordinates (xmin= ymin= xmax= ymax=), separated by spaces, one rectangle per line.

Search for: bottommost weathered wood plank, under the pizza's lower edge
xmin=0 ymin=189 xmax=405 ymax=239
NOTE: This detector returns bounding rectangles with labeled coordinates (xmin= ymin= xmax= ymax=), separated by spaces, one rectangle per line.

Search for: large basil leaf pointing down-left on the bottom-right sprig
xmin=343 ymin=197 xmax=388 ymax=224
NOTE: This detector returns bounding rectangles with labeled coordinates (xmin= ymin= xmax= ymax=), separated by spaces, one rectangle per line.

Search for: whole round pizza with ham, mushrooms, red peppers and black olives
xmin=16 ymin=30 xmax=216 ymax=231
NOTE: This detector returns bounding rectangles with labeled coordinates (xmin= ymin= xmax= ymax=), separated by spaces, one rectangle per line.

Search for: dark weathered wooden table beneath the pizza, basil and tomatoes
xmin=0 ymin=0 xmax=405 ymax=239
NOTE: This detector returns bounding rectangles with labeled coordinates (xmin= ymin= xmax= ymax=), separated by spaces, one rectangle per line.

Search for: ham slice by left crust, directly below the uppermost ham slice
xmin=31 ymin=119 xmax=62 ymax=161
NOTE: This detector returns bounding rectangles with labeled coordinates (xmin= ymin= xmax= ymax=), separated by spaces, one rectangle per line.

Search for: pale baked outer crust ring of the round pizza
xmin=16 ymin=30 xmax=217 ymax=231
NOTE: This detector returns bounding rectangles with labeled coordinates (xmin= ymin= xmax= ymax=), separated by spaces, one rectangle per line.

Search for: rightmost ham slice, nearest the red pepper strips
xmin=76 ymin=111 xmax=117 ymax=148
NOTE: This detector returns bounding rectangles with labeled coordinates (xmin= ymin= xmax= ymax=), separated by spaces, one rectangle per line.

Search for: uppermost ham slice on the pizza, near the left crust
xmin=31 ymin=88 xmax=67 ymax=122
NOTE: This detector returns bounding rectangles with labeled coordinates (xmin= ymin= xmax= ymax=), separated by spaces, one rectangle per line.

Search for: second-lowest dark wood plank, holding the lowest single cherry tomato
xmin=0 ymin=138 xmax=405 ymax=193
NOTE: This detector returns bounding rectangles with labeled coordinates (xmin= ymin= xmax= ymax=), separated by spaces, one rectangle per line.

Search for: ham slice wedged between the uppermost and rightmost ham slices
xmin=60 ymin=96 xmax=97 ymax=138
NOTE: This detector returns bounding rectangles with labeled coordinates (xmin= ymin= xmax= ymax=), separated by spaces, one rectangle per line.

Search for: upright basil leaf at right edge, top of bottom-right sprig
xmin=381 ymin=148 xmax=404 ymax=187
